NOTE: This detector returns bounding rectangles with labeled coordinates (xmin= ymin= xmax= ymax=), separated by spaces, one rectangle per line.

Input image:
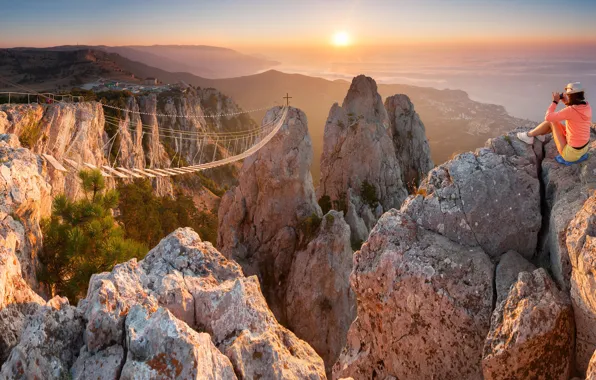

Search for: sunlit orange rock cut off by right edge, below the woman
xmin=566 ymin=194 xmax=596 ymax=373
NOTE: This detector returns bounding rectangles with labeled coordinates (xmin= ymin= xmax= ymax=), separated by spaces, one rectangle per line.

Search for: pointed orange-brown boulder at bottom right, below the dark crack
xmin=482 ymin=268 xmax=574 ymax=380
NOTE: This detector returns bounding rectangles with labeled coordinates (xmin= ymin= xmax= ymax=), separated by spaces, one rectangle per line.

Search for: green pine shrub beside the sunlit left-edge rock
xmin=38 ymin=170 xmax=147 ymax=303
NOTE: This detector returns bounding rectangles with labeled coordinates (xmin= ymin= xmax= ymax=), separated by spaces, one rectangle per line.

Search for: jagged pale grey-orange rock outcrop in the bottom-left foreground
xmin=2 ymin=229 xmax=325 ymax=379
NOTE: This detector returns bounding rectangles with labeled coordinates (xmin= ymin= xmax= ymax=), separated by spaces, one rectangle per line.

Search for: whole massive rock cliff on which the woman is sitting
xmin=333 ymin=129 xmax=596 ymax=379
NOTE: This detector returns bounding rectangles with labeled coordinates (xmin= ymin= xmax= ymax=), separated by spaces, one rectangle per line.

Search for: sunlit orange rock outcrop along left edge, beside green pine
xmin=0 ymin=135 xmax=50 ymax=364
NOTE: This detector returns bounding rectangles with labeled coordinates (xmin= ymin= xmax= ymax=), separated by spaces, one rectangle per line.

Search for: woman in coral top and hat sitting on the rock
xmin=517 ymin=82 xmax=592 ymax=162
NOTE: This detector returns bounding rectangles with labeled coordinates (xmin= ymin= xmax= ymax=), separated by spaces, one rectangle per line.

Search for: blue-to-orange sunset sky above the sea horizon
xmin=0 ymin=0 xmax=596 ymax=50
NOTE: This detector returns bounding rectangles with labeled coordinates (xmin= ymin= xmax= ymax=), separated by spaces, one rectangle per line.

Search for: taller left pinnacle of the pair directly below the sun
xmin=317 ymin=75 xmax=407 ymax=242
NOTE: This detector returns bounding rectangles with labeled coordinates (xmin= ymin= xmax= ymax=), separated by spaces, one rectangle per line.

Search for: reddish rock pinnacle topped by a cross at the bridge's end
xmin=218 ymin=108 xmax=355 ymax=369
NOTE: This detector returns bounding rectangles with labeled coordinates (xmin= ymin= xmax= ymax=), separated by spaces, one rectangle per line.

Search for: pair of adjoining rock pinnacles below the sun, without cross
xmin=317 ymin=75 xmax=433 ymax=245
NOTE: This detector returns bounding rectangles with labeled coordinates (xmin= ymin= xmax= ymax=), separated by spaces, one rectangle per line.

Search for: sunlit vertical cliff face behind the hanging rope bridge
xmin=0 ymin=88 xmax=255 ymax=197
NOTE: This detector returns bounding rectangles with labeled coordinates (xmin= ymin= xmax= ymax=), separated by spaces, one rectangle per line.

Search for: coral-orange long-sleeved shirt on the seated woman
xmin=544 ymin=102 xmax=592 ymax=148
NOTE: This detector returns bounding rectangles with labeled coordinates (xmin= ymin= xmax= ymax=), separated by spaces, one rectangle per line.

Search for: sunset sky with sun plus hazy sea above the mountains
xmin=0 ymin=0 xmax=596 ymax=121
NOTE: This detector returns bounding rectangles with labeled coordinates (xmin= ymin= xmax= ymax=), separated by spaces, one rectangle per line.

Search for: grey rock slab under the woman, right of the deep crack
xmin=542 ymin=137 xmax=596 ymax=290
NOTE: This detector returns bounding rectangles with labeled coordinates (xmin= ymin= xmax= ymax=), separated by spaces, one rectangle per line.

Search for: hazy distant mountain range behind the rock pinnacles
xmin=0 ymin=46 xmax=533 ymax=182
